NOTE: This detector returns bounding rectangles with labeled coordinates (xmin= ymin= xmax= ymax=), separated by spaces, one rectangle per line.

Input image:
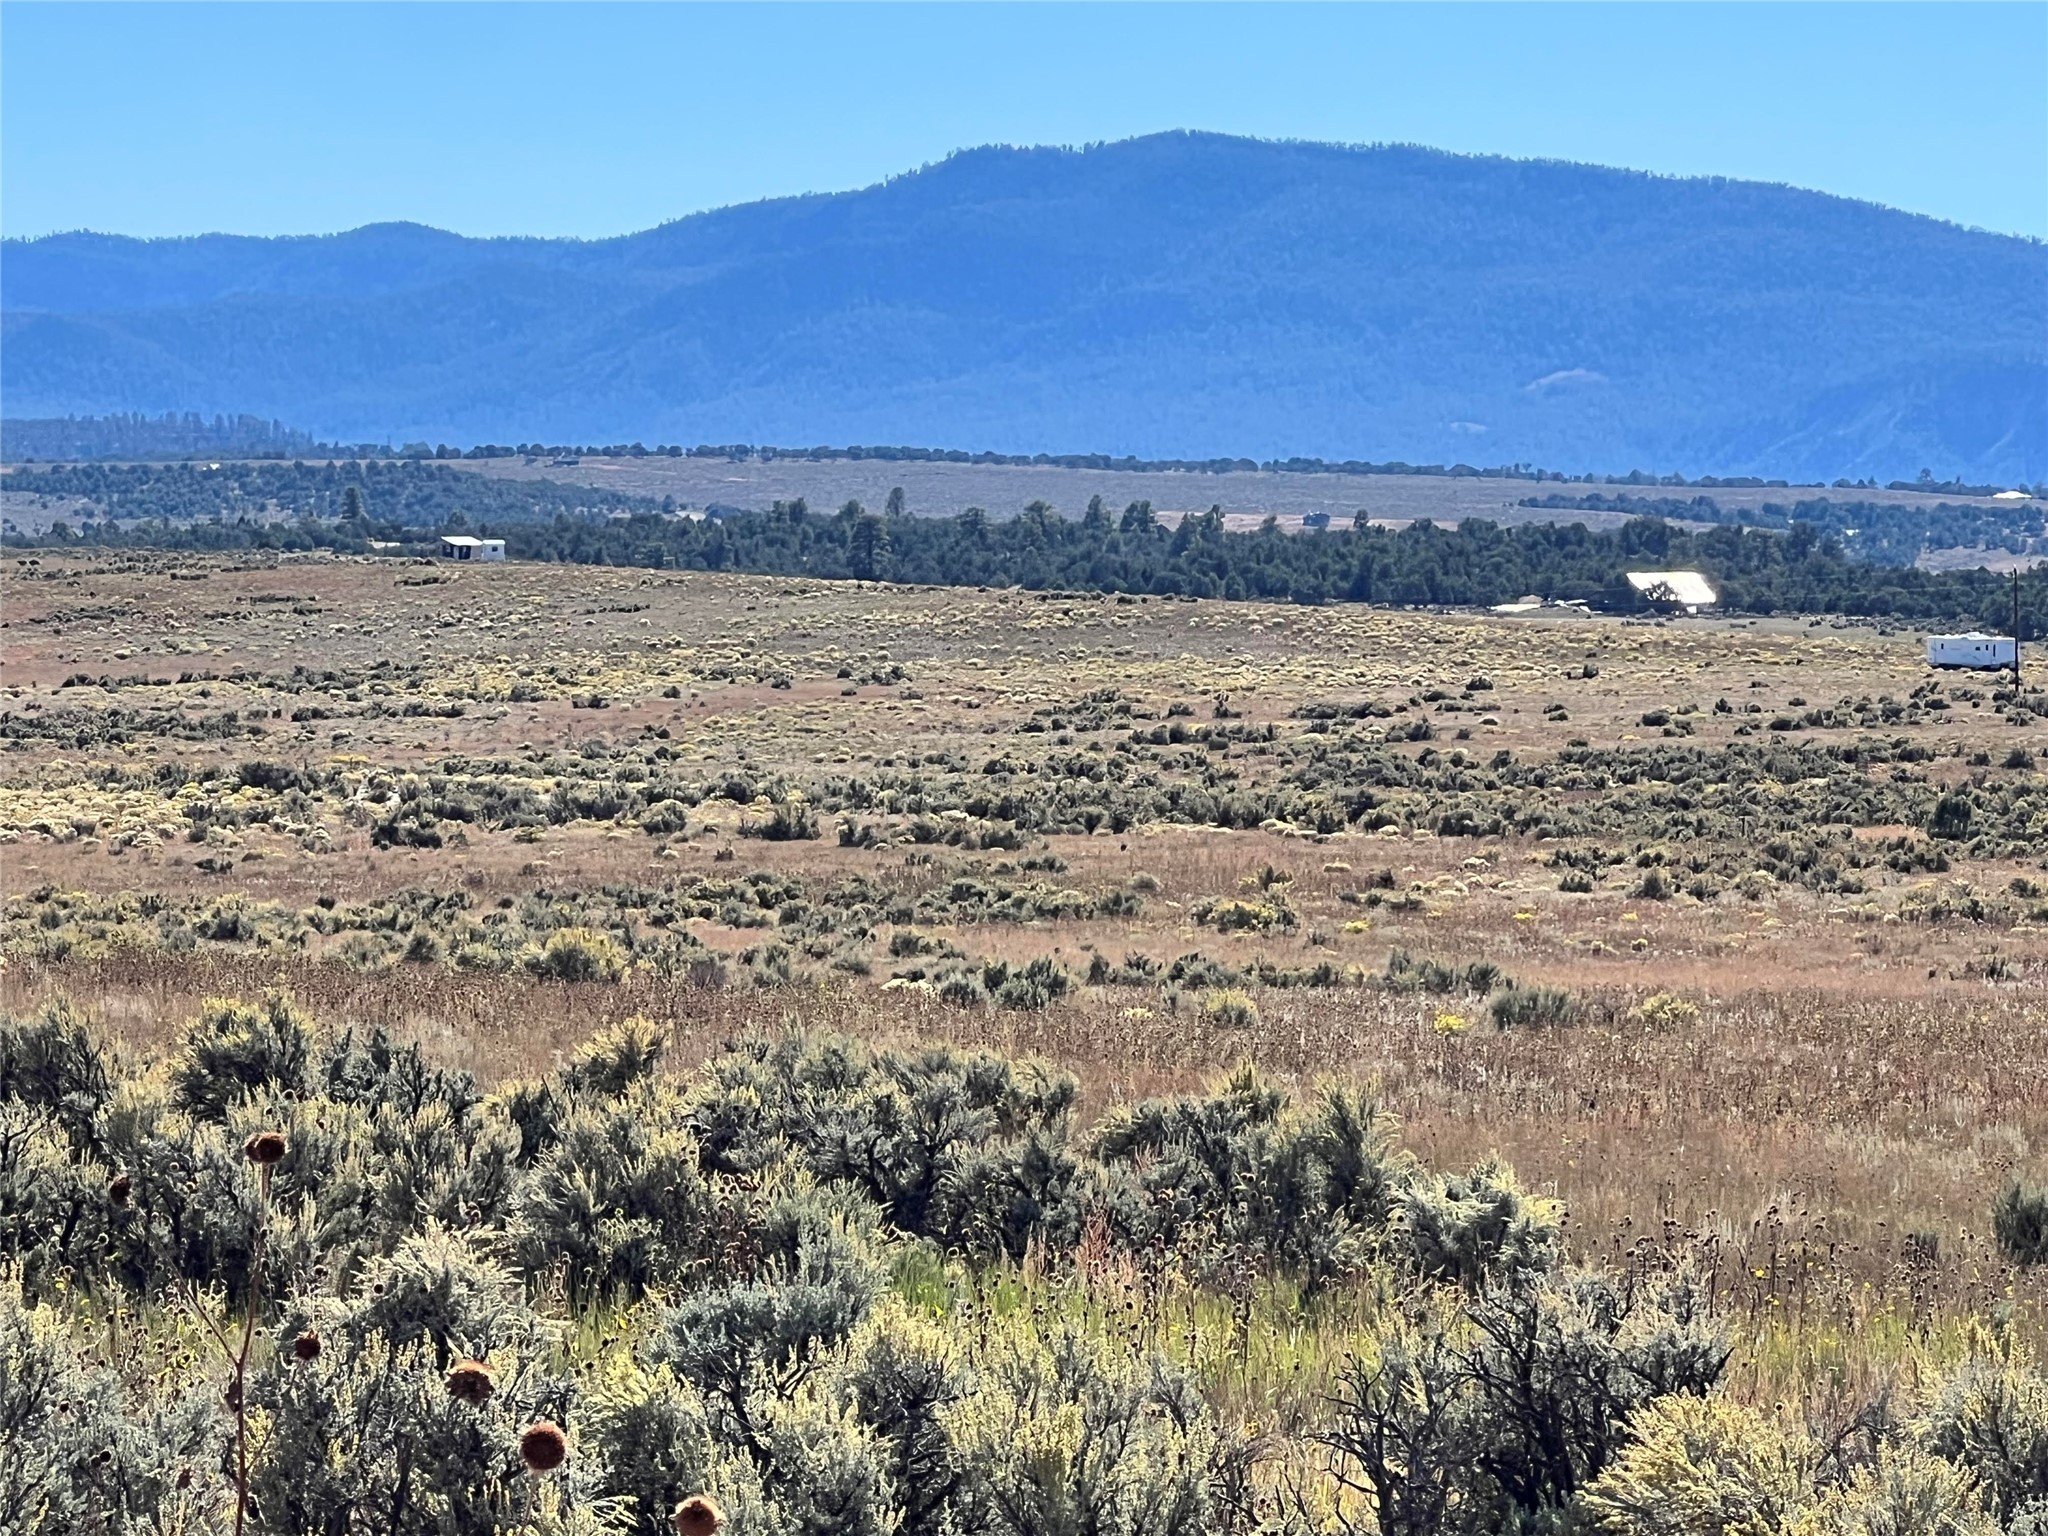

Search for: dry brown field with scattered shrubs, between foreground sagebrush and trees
xmin=0 ymin=548 xmax=2048 ymax=1397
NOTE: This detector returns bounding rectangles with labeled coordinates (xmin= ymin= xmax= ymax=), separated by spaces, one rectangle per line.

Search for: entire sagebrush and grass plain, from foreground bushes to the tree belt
xmin=0 ymin=551 xmax=2048 ymax=1536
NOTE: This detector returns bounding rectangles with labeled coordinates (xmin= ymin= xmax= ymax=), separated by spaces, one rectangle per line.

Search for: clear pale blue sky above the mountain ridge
xmin=12 ymin=0 xmax=2048 ymax=238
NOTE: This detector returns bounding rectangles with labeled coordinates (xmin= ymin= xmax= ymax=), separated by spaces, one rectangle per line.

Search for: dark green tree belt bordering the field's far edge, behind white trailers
xmin=6 ymin=493 xmax=2038 ymax=633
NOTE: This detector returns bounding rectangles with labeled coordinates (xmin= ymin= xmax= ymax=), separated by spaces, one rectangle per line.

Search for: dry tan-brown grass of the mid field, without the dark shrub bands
xmin=0 ymin=557 xmax=2048 ymax=1395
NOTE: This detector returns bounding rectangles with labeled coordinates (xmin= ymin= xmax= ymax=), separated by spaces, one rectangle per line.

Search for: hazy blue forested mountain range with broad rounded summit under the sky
xmin=0 ymin=133 xmax=2048 ymax=481
